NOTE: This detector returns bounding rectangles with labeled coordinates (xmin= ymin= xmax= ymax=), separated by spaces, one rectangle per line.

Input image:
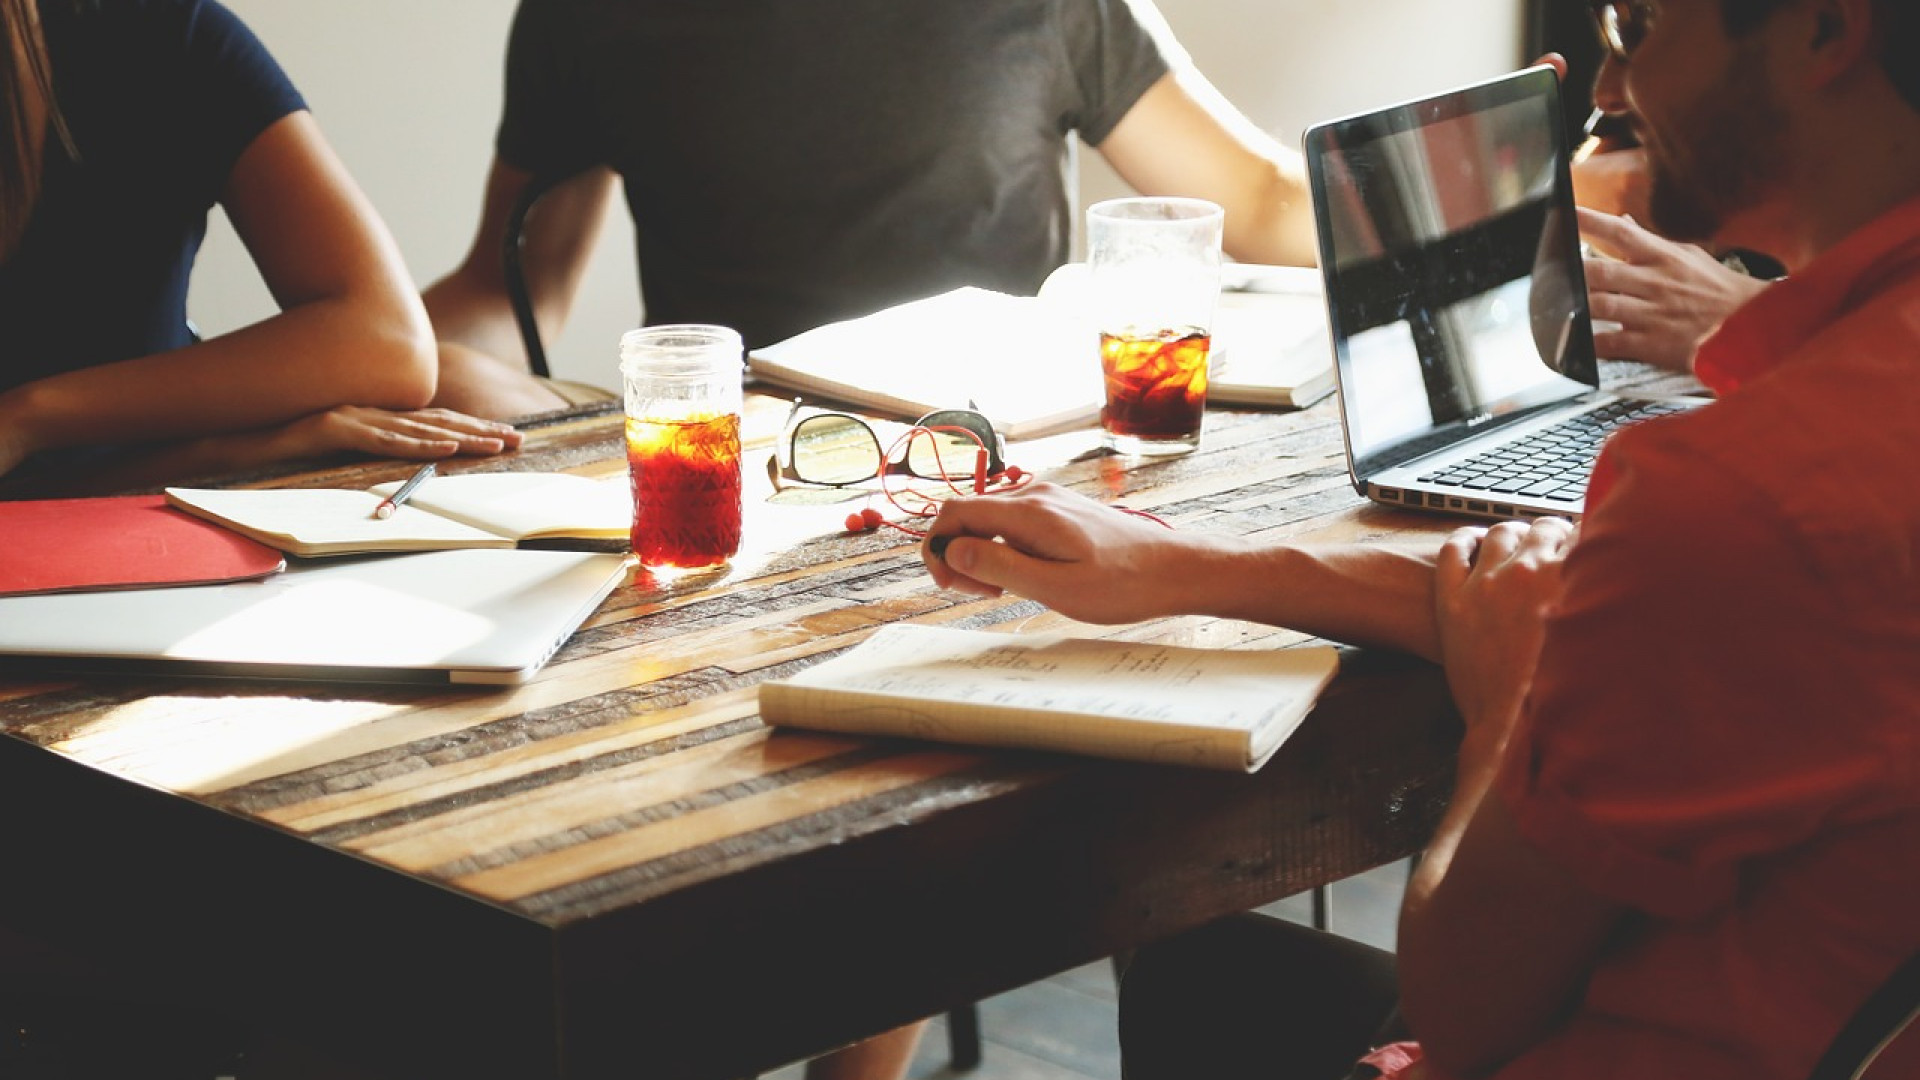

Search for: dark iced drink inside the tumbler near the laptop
xmin=1100 ymin=327 xmax=1212 ymax=454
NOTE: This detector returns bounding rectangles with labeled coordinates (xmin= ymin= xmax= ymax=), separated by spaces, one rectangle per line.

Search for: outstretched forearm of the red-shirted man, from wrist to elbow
xmin=1188 ymin=538 xmax=1440 ymax=659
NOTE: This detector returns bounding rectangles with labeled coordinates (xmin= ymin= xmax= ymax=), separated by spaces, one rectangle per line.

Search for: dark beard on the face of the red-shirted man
xmin=1645 ymin=44 xmax=1786 ymax=242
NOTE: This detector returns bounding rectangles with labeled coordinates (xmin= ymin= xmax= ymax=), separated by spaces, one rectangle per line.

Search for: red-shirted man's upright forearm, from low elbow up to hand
xmin=1400 ymin=519 xmax=1615 ymax=1076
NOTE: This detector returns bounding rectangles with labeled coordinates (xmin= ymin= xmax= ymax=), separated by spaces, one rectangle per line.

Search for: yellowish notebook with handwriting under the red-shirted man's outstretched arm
xmin=760 ymin=623 xmax=1338 ymax=773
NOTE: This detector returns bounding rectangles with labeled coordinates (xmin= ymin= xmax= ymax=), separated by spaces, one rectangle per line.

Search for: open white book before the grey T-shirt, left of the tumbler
xmin=747 ymin=286 xmax=1104 ymax=438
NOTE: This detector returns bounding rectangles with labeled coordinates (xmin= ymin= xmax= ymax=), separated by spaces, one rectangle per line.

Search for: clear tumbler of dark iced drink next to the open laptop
xmin=1087 ymin=198 xmax=1225 ymax=454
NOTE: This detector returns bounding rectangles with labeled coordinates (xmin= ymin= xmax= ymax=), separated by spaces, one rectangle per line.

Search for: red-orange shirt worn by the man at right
xmin=1498 ymin=200 xmax=1920 ymax=1080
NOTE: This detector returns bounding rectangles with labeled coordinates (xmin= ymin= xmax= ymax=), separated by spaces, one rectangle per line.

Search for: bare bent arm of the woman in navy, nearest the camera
xmin=0 ymin=111 xmax=436 ymax=473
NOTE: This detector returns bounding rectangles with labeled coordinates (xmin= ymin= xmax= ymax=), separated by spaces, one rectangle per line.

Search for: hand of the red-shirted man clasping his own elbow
xmin=1434 ymin=517 xmax=1578 ymax=744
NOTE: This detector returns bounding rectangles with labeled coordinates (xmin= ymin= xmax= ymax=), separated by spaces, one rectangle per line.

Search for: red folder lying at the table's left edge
xmin=0 ymin=496 xmax=286 ymax=596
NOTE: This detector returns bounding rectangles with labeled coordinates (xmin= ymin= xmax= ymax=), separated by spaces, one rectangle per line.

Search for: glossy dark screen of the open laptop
xmin=1306 ymin=67 xmax=1599 ymax=477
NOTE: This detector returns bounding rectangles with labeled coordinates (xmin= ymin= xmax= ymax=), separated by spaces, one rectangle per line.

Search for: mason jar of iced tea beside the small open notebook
xmin=620 ymin=325 xmax=743 ymax=571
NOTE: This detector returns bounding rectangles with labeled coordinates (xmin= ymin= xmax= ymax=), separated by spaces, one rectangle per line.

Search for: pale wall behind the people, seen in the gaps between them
xmin=192 ymin=0 xmax=1521 ymax=395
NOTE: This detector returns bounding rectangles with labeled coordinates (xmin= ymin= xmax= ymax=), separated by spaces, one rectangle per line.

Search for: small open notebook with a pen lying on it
xmin=167 ymin=473 xmax=634 ymax=555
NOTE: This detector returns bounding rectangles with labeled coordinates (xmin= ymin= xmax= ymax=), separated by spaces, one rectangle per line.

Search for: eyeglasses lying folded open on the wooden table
xmin=774 ymin=402 xmax=1006 ymax=488
